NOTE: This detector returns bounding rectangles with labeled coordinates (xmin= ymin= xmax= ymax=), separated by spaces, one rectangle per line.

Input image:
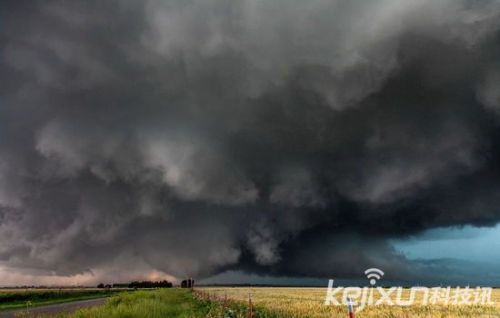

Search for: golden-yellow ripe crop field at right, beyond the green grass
xmin=199 ymin=287 xmax=500 ymax=318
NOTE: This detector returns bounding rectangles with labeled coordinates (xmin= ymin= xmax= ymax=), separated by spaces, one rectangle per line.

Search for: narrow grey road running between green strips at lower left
xmin=0 ymin=298 xmax=107 ymax=318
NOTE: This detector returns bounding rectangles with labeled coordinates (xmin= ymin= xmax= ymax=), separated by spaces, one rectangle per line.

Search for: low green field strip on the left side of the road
xmin=0 ymin=289 xmax=122 ymax=311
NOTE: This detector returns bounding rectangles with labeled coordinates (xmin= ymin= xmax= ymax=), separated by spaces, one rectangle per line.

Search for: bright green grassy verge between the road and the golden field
xmin=58 ymin=288 xmax=277 ymax=318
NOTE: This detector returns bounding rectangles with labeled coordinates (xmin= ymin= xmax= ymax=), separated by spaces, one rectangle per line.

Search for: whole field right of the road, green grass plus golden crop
xmin=6 ymin=287 xmax=500 ymax=318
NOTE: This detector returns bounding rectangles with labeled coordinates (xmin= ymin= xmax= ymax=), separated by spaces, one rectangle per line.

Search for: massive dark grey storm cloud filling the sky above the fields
xmin=0 ymin=0 xmax=500 ymax=284
